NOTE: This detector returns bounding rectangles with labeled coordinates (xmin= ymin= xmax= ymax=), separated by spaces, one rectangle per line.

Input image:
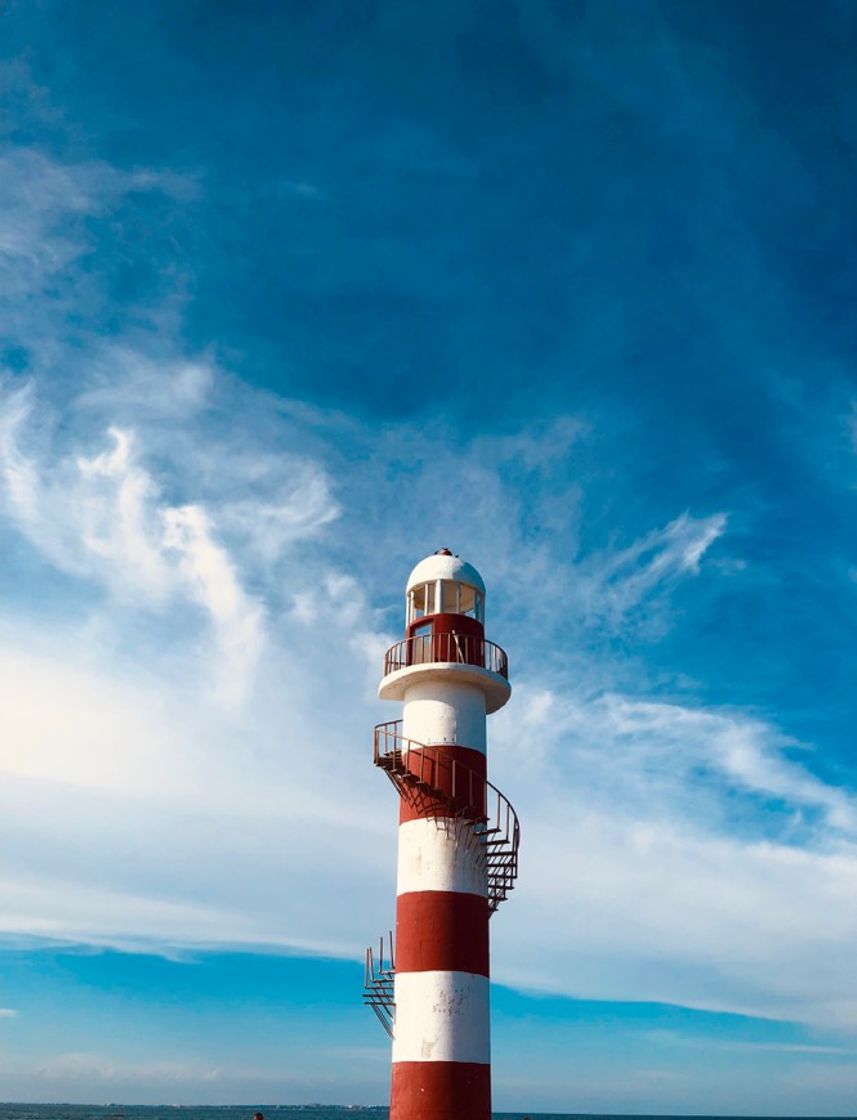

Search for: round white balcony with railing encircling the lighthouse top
xmin=378 ymin=634 xmax=512 ymax=712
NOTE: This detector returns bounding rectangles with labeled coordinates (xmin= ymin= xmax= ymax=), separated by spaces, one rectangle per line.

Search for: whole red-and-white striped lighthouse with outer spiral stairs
xmin=364 ymin=549 xmax=520 ymax=1120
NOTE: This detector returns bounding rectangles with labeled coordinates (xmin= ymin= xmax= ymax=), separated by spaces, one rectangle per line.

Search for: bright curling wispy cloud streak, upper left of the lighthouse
xmin=0 ymin=398 xmax=264 ymax=698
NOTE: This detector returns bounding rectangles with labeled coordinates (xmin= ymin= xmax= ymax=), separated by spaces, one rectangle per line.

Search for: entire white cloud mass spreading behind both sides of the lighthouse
xmin=0 ymin=142 xmax=857 ymax=1048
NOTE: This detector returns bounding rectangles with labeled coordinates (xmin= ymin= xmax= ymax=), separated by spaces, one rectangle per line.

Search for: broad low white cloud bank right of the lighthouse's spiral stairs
xmin=494 ymin=684 xmax=857 ymax=1026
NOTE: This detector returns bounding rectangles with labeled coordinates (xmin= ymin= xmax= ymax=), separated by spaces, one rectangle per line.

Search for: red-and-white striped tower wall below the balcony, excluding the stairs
xmin=390 ymin=673 xmax=491 ymax=1120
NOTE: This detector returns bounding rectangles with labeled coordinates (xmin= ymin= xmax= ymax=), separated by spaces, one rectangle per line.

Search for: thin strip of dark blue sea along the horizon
xmin=0 ymin=1104 xmax=812 ymax=1120
